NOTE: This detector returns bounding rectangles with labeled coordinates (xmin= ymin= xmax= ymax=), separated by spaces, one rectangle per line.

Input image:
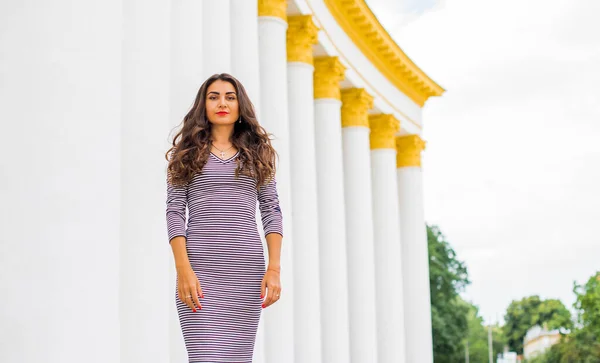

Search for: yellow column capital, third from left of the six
xmin=313 ymin=57 xmax=346 ymax=100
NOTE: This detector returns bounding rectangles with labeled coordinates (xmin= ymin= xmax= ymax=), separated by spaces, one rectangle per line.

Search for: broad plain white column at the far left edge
xmin=0 ymin=0 xmax=122 ymax=363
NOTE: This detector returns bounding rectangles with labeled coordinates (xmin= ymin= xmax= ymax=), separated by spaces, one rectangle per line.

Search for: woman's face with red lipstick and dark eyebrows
xmin=206 ymin=79 xmax=240 ymax=125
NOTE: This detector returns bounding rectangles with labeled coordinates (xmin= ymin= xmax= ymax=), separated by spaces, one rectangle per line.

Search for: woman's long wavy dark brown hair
xmin=165 ymin=73 xmax=277 ymax=189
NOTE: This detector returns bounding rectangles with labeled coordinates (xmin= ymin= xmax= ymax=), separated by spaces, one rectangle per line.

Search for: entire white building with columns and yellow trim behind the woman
xmin=0 ymin=0 xmax=443 ymax=363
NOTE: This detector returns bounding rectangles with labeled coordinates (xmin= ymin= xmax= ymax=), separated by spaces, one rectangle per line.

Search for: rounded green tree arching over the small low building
xmin=504 ymin=296 xmax=573 ymax=354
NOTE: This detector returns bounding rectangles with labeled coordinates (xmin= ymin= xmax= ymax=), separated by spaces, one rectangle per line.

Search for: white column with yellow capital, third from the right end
xmin=342 ymin=88 xmax=378 ymax=363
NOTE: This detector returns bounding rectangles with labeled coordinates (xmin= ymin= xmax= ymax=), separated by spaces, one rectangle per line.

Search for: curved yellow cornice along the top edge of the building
xmin=323 ymin=0 xmax=444 ymax=106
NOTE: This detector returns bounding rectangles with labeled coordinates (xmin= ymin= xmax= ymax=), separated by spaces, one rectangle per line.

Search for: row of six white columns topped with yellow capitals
xmin=258 ymin=1 xmax=433 ymax=363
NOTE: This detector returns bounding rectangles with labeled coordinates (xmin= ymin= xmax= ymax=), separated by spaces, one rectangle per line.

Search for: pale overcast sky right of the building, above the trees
xmin=367 ymin=0 xmax=600 ymax=321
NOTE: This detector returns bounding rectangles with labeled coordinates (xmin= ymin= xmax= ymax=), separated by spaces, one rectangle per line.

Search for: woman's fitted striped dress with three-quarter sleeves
xmin=166 ymin=151 xmax=283 ymax=363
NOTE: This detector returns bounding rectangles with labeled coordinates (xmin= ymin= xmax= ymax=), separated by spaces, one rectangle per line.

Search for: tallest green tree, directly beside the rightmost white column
xmin=427 ymin=226 xmax=469 ymax=363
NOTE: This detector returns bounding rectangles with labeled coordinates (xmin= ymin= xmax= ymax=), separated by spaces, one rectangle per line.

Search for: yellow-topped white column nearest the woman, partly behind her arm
xmin=258 ymin=0 xmax=295 ymax=363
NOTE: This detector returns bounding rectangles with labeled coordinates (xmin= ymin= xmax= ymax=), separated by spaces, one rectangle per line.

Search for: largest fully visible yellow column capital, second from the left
xmin=287 ymin=15 xmax=319 ymax=65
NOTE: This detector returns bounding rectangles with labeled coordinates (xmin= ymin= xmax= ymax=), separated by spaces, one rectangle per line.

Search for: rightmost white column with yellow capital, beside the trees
xmin=396 ymin=135 xmax=433 ymax=363
